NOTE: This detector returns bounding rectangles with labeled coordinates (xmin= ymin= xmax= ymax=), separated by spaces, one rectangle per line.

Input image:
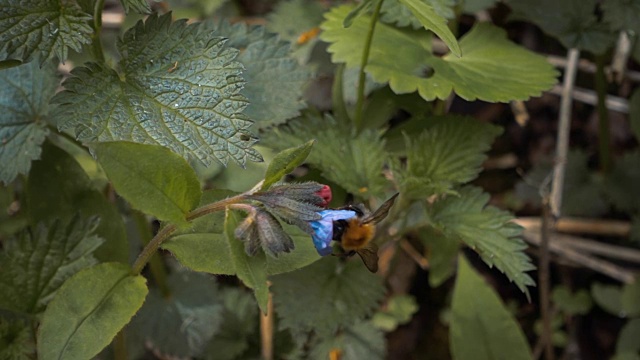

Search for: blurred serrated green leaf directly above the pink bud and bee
xmin=264 ymin=114 xmax=388 ymax=197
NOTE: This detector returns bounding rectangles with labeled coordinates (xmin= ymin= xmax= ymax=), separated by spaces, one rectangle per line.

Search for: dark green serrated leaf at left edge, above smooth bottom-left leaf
xmin=0 ymin=217 xmax=104 ymax=314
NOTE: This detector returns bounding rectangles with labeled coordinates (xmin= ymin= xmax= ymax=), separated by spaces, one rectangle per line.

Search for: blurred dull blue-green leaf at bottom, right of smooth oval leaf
xmin=131 ymin=270 xmax=223 ymax=359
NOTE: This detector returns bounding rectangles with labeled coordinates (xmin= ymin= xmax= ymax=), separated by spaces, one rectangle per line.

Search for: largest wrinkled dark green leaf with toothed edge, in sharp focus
xmin=53 ymin=14 xmax=261 ymax=166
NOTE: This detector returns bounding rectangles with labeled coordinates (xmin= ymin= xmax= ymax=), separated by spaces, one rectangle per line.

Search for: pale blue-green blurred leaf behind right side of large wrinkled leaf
xmin=205 ymin=22 xmax=311 ymax=128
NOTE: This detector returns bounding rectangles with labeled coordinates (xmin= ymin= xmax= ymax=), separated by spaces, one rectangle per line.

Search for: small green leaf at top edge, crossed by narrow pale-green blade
xmin=380 ymin=0 xmax=456 ymax=29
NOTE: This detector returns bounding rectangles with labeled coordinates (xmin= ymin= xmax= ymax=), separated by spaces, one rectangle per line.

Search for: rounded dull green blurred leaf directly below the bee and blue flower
xmin=271 ymin=257 xmax=384 ymax=336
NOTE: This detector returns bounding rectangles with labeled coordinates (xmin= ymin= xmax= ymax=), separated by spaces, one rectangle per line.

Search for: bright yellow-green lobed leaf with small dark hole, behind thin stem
xmin=321 ymin=6 xmax=557 ymax=102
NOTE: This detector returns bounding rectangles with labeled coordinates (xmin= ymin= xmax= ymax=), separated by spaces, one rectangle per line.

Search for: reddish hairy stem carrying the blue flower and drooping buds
xmin=131 ymin=194 xmax=246 ymax=275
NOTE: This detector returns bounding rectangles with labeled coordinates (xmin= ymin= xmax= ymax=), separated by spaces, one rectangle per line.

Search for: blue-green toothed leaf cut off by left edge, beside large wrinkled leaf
xmin=0 ymin=62 xmax=58 ymax=184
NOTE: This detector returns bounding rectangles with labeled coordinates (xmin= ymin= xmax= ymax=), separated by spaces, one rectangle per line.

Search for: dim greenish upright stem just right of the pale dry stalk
xmin=595 ymin=55 xmax=611 ymax=174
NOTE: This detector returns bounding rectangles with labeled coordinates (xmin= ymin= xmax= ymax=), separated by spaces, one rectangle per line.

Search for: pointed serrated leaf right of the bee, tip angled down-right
xmin=430 ymin=187 xmax=535 ymax=297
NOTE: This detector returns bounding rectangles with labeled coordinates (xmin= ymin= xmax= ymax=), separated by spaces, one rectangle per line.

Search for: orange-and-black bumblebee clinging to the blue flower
xmin=332 ymin=194 xmax=398 ymax=272
